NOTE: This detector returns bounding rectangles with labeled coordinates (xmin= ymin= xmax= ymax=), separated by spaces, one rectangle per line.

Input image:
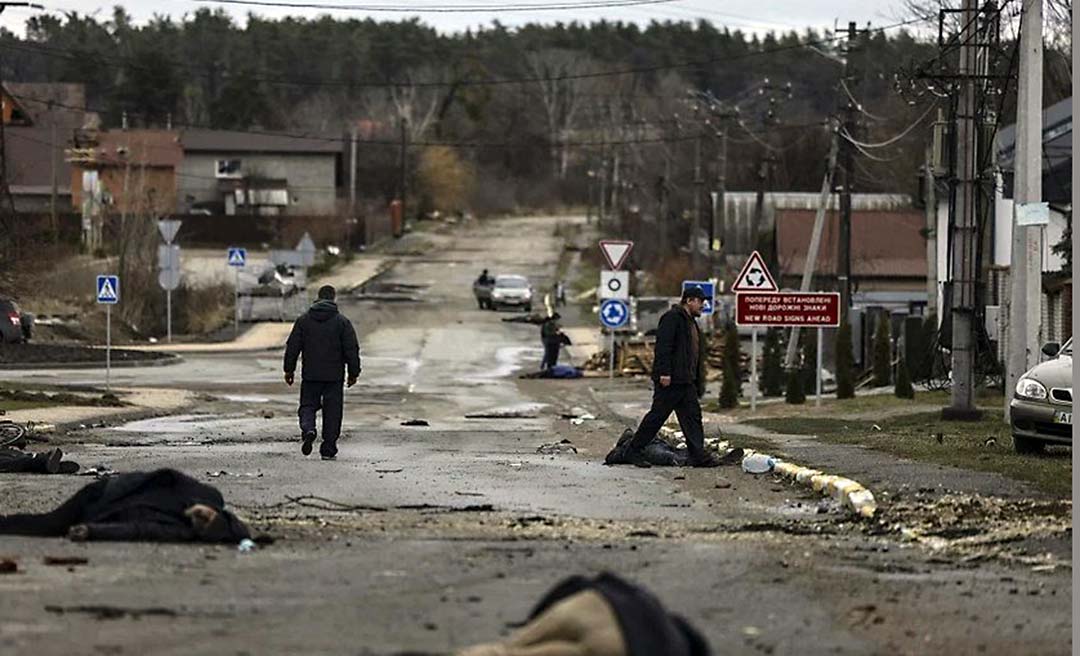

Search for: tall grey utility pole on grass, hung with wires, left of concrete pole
xmin=942 ymin=0 xmax=984 ymax=420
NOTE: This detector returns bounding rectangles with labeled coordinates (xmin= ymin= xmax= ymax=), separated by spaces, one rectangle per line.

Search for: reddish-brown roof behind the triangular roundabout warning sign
xmin=777 ymin=210 xmax=927 ymax=278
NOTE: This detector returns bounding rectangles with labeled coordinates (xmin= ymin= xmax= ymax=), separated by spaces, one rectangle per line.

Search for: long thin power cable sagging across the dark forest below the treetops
xmin=0 ymin=18 xmax=924 ymax=89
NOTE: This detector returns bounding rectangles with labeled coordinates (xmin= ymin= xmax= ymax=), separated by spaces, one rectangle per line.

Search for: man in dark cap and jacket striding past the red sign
xmin=627 ymin=287 xmax=720 ymax=467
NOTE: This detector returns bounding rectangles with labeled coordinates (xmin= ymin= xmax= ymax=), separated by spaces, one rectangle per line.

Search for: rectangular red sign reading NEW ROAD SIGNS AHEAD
xmin=735 ymin=292 xmax=840 ymax=327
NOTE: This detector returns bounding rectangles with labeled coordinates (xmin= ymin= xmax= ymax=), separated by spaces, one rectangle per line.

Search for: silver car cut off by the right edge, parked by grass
xmin=1009 ymin=339 xmax=1072 ymax=453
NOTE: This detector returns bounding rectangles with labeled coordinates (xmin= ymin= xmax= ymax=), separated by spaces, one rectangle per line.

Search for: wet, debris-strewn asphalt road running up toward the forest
xmin=0 ymin=218 xmax=1071 ymax=654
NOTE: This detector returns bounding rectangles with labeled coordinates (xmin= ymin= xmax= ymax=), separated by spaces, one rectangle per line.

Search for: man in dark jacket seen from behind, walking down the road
xmin=285 ymin=285 xmax=360 ymax=460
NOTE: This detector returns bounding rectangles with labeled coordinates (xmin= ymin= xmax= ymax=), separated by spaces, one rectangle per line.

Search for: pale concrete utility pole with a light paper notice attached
xmin=1004 ymin=0 xmax=1044 ymax=420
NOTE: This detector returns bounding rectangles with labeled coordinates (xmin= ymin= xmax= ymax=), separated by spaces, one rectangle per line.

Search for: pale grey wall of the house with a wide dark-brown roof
xmin=177 ymin=152 xmax=337 ymax=215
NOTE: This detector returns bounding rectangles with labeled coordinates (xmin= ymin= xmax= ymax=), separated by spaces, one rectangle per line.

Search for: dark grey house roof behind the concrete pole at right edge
xmin=998 ymin=97 xmax=1072 ymax=202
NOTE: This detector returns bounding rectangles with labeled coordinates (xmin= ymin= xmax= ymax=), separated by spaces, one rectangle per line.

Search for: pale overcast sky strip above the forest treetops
xmin=0 ymin=0 xmax=920 ymax=35
